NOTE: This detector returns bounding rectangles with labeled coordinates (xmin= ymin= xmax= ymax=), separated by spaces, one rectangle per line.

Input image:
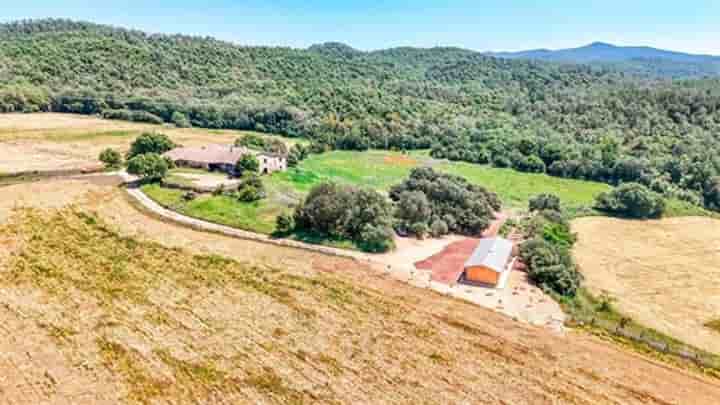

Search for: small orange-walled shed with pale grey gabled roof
xmin=463 ymin=237 xmax=513 ymax=287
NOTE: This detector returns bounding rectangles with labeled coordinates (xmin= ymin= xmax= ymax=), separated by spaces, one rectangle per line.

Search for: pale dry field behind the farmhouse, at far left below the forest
xmin=0 ymin=113 xmax=296 ymax=173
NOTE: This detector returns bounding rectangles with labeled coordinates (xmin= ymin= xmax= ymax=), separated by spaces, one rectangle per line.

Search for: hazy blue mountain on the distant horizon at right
xmin=486 ymin=42 xmax=720 ymax=77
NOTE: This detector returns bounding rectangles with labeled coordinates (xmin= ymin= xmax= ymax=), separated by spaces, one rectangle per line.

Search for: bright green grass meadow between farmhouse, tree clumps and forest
xmin=143 ymin=151 xmax=610 ymax=235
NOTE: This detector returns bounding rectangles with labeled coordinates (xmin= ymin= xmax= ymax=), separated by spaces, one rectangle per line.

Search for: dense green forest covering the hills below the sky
xmin=0 ymin=20 xmax=720 ymax=207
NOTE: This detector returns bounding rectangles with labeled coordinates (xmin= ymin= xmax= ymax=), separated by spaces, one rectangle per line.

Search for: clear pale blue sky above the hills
xmin=5 ymin=0 xmax=720 ymax=55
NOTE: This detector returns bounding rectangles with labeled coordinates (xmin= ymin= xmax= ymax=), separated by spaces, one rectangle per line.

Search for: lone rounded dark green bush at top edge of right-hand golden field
xmin=595 ymin=183 xmax=665 ymax=218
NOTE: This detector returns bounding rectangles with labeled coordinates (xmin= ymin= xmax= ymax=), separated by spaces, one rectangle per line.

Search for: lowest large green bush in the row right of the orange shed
xmin=520 ymin=239 xmax=583 ymax=297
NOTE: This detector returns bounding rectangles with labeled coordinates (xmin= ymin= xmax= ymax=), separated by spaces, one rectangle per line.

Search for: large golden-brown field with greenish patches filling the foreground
xmin=0 ymin=177 xmax=720 ymax=404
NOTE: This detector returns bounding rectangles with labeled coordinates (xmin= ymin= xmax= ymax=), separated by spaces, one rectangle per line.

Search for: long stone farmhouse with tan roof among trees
xmin=163 ymin=145 xmax=287 ymax=175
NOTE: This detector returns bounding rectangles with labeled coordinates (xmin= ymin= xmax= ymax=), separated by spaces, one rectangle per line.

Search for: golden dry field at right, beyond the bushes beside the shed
xmin=573 ymin=217 xmax=720 ymax=353
